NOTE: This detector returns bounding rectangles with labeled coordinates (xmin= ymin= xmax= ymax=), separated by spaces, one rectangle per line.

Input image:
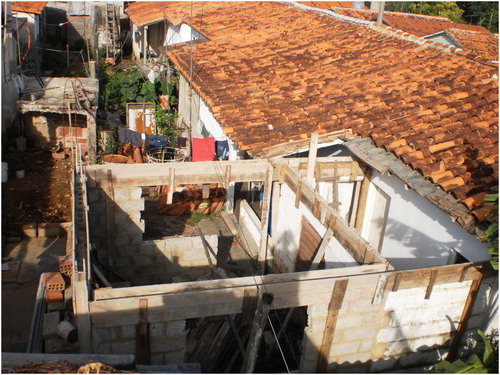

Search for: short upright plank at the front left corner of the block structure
xmin=73 ymin=272 xmax=92 ymax=354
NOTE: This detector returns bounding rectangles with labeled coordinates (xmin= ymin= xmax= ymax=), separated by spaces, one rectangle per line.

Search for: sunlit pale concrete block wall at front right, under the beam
xmin=300 ymin=275 xmax=478 ymax=373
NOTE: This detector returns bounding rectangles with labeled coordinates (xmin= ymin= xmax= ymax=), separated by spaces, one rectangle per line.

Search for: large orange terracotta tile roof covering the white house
xmin=150 ymin=2 xmax=498 ymax=226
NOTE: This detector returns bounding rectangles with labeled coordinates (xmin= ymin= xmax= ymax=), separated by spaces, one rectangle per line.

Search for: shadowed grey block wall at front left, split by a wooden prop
xmin=92 ymin=320 xmax=187 ymax=365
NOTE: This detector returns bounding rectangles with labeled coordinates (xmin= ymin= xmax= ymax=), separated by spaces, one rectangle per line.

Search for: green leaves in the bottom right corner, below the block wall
xmin=431 ymin=330 xmax=498 ymax=374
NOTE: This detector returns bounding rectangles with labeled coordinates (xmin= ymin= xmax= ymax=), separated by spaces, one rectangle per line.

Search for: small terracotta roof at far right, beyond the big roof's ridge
xmin=445 ymin=28 xmax=499 ymax=61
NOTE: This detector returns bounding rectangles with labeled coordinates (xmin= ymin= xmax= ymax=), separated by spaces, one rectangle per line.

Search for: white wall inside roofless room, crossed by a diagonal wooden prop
xmin=273 ymin=184 xmax=358 ymax=272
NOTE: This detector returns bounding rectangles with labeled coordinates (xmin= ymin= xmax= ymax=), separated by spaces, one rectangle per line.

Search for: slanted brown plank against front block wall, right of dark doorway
xmin=317 ymin=279 xmax=349 ymax=373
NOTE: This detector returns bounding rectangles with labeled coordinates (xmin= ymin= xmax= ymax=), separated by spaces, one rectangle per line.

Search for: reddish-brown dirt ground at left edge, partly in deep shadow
xmin=2 ymin=149 xmax=71 ymax=237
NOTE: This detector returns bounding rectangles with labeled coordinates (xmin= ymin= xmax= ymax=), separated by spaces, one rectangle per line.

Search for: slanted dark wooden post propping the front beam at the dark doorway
xmin=241 ymin=292 xmax=273 ymax=374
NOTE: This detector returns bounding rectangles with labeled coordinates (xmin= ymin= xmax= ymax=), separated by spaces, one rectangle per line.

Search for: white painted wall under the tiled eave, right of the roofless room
xmin=362 ymin=171 xmax=490 ymax=270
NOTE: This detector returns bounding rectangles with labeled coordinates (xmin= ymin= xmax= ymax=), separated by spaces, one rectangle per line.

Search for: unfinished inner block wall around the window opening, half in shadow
xmin=88 ymin=181 xmax=217 ymax=285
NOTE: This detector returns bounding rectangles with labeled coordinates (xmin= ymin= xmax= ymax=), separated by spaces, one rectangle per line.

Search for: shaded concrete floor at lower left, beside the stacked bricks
xmin=2 ymin=237 xmax=66 ymax=352
